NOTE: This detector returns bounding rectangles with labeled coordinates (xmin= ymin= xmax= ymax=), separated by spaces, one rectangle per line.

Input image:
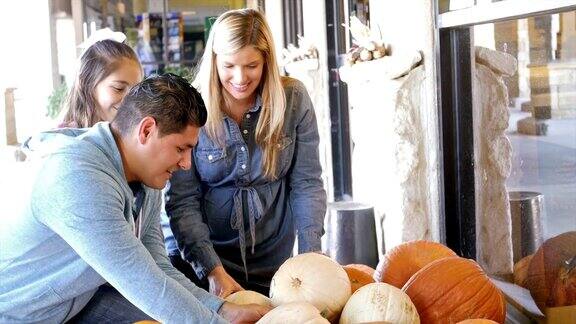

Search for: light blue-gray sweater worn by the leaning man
xmin=0 ymin=123 xmax=230 ymax=323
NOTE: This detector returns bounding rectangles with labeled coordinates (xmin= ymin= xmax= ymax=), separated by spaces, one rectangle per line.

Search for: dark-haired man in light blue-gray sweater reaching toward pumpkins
xmin=0 ymin=75 xmax=268 ymax=323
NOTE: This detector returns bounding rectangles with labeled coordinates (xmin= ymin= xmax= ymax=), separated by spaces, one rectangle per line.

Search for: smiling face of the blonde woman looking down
xmin=216 ymin=46 xmax=264 ymax=103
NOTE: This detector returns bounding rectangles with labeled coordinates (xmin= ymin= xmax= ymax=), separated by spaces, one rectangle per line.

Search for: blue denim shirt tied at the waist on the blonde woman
xmin=164 ymin=78 xmax=326 ymax=286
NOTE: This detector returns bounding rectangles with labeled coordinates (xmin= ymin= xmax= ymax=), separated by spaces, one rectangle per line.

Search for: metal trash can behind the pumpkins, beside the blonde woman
xmin=324 ymin=201 xmax=378 ymax=267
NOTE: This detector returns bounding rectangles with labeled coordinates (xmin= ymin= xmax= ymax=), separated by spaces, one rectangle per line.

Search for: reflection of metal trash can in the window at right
xmin=508 ymin=191 xmax=544 ymax=263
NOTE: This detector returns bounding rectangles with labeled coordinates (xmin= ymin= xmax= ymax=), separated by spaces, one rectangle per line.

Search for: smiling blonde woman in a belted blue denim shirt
xmin=164 ymin=9 xmax=326 ymax=297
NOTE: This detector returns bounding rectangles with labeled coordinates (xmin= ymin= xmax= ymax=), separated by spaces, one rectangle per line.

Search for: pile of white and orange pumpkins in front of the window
xmin=243 ymin=241 xmax=508 ymax=324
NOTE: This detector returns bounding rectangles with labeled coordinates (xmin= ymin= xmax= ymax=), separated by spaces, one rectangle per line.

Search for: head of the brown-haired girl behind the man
xmin=60 ymin=39 xmax=143 ymax=128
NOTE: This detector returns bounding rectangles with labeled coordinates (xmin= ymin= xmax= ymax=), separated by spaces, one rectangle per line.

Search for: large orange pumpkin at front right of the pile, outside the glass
xmin=402 ymin=257 xmax=506 ymax=324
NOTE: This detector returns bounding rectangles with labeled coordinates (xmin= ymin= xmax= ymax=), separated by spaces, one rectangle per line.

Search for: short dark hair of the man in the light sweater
xmin=112 ymin=73 xmax=207 ymax=136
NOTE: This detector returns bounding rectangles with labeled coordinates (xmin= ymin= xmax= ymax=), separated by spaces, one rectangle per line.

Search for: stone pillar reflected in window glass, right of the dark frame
xmin=473 ymin=47 xmax=516 ymax=275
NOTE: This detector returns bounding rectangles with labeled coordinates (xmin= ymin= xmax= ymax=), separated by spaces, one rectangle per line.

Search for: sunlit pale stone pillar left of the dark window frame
xmin=340 ymin=52 xmax=436 ymax=252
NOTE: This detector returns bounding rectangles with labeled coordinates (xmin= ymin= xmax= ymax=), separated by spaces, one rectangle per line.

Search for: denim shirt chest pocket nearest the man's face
xmin=195 ymin=148 xmax=229 ymax=183
